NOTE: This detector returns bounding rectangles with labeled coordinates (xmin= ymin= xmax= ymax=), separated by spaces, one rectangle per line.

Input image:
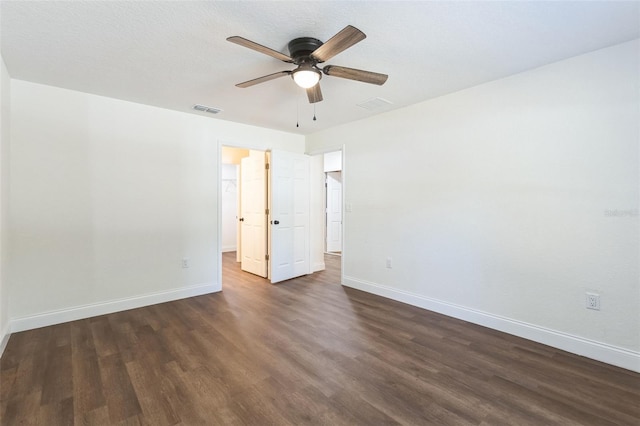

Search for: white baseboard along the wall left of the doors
xmin=10 ymin=283 xmax=222 ymax=333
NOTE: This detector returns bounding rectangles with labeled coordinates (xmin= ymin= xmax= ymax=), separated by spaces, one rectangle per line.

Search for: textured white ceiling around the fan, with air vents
xmin=0 ymin=0 xmax=640 ymax=134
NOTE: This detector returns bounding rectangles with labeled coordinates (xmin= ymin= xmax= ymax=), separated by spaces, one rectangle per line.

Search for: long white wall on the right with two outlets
xmin=307 ymin=40 xmax=640 ymax=371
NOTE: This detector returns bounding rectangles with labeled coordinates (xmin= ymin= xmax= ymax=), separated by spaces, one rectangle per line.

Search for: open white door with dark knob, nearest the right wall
xmin=269 ymin=151 xmax=311 ymax=283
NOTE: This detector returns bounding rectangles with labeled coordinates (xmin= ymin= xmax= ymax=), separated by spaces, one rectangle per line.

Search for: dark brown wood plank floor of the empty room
xmin=0 ymin=253 xmax=640 ymax=426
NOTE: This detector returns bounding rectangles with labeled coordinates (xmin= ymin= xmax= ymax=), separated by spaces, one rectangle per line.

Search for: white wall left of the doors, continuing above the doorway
xmin=9 ymin=80 xmax=304 ymax=331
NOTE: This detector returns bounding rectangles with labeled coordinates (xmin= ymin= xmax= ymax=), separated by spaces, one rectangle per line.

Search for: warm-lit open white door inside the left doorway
xmin=239 ymin=151 xmax=267 ymax=277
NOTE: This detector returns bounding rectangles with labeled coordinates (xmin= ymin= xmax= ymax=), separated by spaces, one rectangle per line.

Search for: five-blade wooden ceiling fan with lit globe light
xmin=227 ymin=25 xmax=388 ymax=103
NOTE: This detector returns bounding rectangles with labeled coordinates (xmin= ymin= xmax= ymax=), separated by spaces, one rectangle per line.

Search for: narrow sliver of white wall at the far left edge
xmin=0 ymin=57 xmax=11 ymax=356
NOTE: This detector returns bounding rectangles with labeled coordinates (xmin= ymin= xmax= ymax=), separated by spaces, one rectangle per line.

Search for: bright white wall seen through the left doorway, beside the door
xmin=220 ymin=164 xmax=239 ymax=252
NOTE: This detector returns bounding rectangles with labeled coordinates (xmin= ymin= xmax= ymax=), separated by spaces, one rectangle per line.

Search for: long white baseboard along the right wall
xmin=342 ymin=276 xmax=640 ymax=373
